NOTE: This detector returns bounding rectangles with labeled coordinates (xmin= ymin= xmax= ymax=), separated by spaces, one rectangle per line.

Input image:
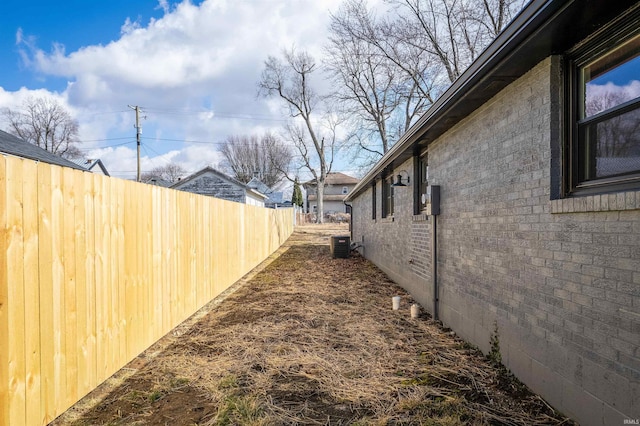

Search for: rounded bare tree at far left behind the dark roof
xmin=1 ymin=97 xmax=81 ymax=158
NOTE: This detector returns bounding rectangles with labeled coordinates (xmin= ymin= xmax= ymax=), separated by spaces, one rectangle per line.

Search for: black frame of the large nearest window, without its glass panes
xmin=563 ymin=11 xmax=640 ymax=197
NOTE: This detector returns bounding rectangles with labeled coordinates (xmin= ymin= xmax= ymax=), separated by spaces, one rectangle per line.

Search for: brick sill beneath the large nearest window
xmin=551 ymin=191 xmax=640 ymax=214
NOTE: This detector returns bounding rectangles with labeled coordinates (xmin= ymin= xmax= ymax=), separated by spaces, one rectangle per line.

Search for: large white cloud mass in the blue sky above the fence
xmin=0 ymin=0 xmax=342 ymax=177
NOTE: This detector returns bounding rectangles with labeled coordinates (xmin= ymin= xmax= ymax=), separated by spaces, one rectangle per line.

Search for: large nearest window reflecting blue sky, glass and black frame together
xmin=565 ymin=28 xmax=640 ymax=195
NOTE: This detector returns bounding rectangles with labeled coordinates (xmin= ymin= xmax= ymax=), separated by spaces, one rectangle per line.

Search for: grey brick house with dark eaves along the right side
xmin=347 ymin=0 xmax=640 ymax=425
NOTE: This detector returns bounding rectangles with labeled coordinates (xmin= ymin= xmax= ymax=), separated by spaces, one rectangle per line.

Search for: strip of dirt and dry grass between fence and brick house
xmin=53 ymin=224 xmax=572 ymax=425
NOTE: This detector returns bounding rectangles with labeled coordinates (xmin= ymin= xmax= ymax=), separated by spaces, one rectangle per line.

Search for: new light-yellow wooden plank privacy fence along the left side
xmin=0 ymin=156 xmax=293 ymax=426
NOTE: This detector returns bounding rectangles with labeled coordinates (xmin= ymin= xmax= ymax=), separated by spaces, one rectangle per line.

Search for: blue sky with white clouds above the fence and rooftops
xmin=0 ymin=0 xmax=353 ymax=179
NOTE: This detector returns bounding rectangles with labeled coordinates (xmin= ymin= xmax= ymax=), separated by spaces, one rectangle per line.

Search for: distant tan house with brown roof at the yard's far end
xmin=302 ymin=172 xmax=359 ymax=214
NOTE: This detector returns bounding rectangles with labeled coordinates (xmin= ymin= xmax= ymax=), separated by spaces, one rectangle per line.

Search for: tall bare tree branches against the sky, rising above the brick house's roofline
xmin=327 ymin=0 xmax=525 ymax=166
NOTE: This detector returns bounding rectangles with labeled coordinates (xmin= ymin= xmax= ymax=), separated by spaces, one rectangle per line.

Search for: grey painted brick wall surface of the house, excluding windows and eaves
xmin=353 ymin=58 xmax=640 ymax=424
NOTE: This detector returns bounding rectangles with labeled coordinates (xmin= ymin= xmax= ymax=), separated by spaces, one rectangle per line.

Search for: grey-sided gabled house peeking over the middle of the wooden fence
xmin=171 ymin=167 xmax=268 ymax=207
